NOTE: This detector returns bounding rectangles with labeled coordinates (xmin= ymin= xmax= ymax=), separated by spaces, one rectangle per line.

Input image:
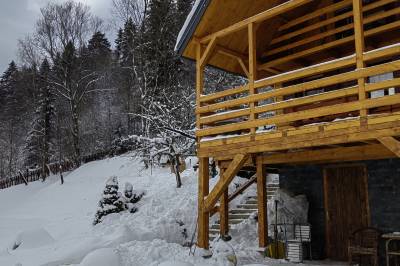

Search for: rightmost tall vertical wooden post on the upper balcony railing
xmin=353 ymin=0 xmax=367 ymax=123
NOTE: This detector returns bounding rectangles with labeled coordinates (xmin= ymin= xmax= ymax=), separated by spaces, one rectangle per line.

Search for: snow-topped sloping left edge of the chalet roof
xmin=175 ymin=0 xmax=210 ymax=54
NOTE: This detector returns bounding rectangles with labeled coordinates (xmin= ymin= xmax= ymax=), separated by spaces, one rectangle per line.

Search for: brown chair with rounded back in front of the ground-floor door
xmin=348 ymin=227 xmax=381 ymax=266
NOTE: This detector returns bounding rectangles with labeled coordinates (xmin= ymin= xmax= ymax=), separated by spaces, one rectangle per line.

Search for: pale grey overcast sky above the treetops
xmin=0 ymin=0 xmax=114 ymax=72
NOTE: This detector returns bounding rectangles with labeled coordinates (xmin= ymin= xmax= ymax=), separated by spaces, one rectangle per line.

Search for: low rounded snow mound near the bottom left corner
xmin=11 ymin=228 xmax=54 ymax=249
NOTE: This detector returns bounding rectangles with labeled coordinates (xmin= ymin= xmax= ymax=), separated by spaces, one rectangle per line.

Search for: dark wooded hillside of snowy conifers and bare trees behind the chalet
xmin=0 ymin=0 xmax=242 ymax=181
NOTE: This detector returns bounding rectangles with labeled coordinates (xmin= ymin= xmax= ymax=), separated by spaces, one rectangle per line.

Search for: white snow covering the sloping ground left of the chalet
xmin=0 ymin=155 xmax=344 ymax=266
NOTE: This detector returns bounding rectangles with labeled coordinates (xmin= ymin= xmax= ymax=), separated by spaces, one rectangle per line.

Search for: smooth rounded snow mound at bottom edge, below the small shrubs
xmin=79 ymin=248 xmax=120 ymax=266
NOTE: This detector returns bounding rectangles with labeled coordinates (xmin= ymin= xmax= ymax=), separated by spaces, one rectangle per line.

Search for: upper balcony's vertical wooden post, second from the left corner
xmin=248 ymin=23 xmax=257 ymax=135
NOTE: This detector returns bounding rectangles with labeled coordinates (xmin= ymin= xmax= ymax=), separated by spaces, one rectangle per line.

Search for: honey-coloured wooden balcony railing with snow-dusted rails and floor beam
xmin=196 ymin=44 xmax=400 ymax=163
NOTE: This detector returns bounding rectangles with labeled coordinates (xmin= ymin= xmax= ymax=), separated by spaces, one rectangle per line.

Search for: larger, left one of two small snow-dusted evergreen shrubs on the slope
xmin=93 ymin=176 xmax=125 ymax=225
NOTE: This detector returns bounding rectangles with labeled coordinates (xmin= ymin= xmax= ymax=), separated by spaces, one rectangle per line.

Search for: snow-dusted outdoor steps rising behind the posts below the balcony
xmin=209 ymin=184 xmax=279 ymax=241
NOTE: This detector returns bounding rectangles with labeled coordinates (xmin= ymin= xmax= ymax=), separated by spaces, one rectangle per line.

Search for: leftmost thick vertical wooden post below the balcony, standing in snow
xmin=197 ymin=158 xmax=210 ymax=249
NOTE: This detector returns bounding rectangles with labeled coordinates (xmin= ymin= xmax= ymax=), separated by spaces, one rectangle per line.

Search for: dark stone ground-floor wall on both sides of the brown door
xmin=280 ymin=159 xmax=400 ymax=258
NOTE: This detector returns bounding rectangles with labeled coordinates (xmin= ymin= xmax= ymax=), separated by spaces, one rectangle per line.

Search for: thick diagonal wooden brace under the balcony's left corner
xmin=204 ymin=153 xmax=248 ymax=211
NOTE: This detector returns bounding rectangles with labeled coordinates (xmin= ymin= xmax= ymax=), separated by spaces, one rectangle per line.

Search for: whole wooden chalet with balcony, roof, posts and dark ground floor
xmin=176 ymin=0 xmax=400 ymax=259
